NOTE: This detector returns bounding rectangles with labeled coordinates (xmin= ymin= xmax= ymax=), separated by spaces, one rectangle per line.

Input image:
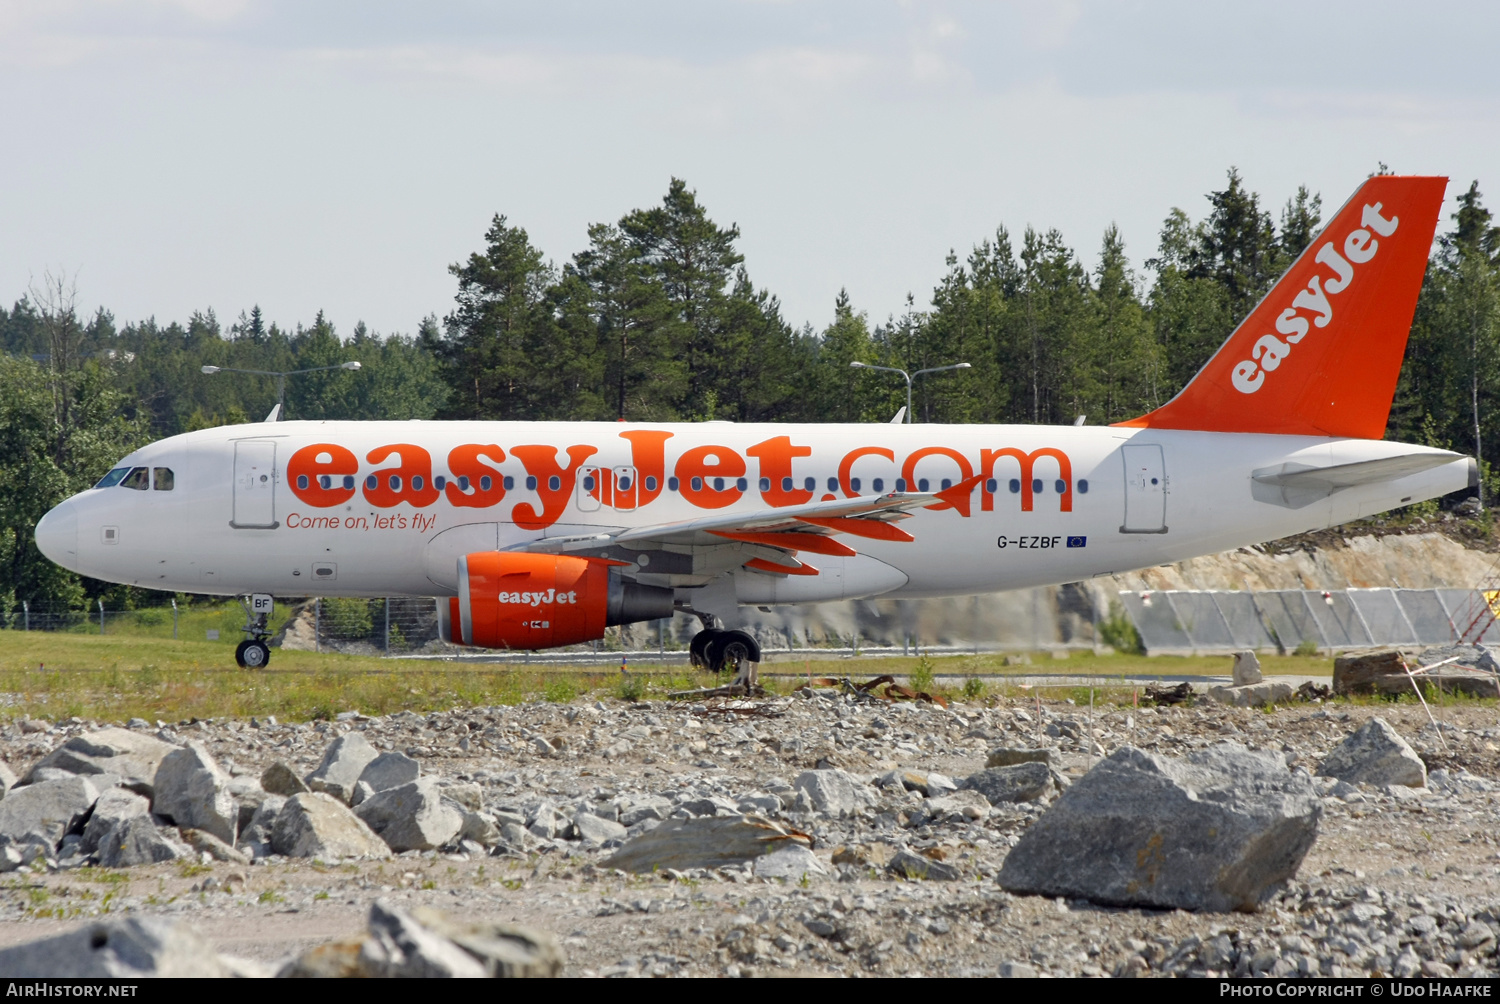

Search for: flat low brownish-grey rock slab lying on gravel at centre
xmin=603 ymin=816 xmax=812 ymax=873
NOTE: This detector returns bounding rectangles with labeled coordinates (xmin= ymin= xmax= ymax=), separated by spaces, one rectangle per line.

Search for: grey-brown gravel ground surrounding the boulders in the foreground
xmin=0 ymin=690 xmax=1500 ymax=975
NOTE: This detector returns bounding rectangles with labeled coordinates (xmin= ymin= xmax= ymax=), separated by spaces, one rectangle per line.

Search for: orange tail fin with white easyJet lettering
xmin=1118 ymin=174 xmax=1448 ymax=440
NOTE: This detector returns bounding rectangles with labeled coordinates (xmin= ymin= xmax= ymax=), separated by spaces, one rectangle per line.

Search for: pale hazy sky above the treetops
xmin=0 ymin=0 xmax=1500 ymax=333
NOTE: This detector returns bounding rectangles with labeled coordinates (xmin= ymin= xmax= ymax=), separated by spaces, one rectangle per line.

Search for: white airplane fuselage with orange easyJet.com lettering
xmin=36 ymin=422 xmax=1470 ymax=603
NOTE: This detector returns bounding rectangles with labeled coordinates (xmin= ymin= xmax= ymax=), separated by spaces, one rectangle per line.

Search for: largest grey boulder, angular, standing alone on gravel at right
xmin=999 ymin=743 xmax=1323 ymax=911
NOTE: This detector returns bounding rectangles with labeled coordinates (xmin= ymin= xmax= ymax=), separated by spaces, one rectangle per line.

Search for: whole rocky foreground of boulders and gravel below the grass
xmin=0 ymin=690 xmax=1500 ymax=975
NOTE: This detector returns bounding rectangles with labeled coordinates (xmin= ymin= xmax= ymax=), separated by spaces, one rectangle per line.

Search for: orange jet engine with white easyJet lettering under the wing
xmin=438 ymin=551 xmax=672 ymax=651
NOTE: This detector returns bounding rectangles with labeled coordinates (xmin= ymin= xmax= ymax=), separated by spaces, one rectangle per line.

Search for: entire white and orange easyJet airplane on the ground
xmin=36 ymin=176 xmax=1478 ymax=669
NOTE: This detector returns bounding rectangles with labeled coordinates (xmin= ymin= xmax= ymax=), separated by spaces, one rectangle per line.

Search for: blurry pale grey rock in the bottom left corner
xmin=0 ymin=917 xmax=230 ymax=980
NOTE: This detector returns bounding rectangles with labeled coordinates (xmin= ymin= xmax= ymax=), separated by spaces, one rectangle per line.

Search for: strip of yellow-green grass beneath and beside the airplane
xmin=0 ymin=627 xmax=1338 ymax=722
